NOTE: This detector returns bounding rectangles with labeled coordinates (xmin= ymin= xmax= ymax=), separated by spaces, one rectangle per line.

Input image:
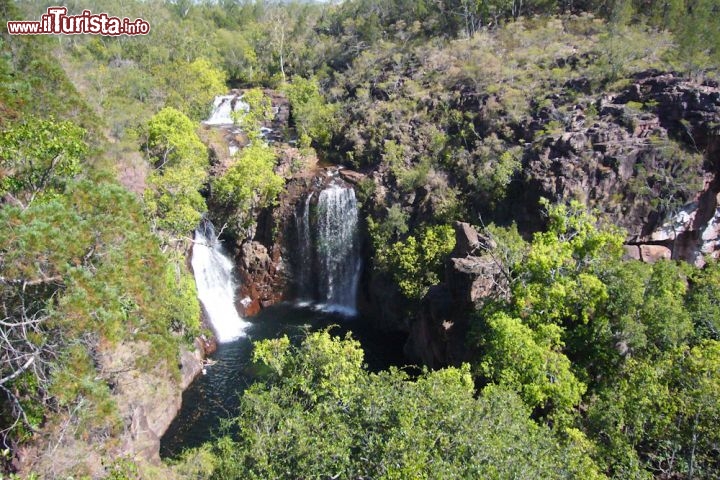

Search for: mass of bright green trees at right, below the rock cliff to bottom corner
xmin=475 ymin=202 xmax=720 ymax=478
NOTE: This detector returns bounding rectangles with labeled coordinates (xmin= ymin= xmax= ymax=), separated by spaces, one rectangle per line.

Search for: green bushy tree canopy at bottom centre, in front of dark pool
xmin=189 ymin=331 xmax=602 ymax=479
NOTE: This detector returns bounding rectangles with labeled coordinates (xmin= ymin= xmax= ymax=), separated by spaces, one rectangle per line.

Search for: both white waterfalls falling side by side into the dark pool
xmin=192 ymin=185 xmax=361 ymax=343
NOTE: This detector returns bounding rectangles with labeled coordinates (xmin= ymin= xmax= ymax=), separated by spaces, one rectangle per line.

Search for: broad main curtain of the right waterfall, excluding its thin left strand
xmin=316 ymin=185 xmax=360 ymax=314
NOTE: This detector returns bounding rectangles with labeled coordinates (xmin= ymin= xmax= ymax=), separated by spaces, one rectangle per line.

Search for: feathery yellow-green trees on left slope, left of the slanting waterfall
xmin=0 ymin=181 xmax=200 ymax=448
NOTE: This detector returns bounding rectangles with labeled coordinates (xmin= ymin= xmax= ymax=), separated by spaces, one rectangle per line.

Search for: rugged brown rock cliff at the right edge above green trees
xmin=510 ymin=72 xmax=720 ymax=264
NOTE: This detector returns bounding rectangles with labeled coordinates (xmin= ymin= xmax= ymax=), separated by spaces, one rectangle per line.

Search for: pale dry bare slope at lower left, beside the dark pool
xmin=17 ymin=342 xmax=203 ymax=478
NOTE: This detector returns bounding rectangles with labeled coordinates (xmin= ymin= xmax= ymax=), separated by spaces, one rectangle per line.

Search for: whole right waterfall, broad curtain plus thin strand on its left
xmin=295 ymin=184 xmax=361 ymax=315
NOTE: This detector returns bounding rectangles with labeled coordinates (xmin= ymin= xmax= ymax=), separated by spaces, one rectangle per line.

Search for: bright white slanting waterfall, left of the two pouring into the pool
xmin=192 ymin=221 xmax=248 ymax=342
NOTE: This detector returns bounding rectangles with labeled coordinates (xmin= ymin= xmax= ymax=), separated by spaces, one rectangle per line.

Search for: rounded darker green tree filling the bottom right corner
xmin=586 ymin=340 xmax=720 ymax=478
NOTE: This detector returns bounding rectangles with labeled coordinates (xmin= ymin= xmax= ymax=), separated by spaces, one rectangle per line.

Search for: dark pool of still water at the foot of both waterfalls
xmin=160 ymin=304 xmax=406 ymax=458
